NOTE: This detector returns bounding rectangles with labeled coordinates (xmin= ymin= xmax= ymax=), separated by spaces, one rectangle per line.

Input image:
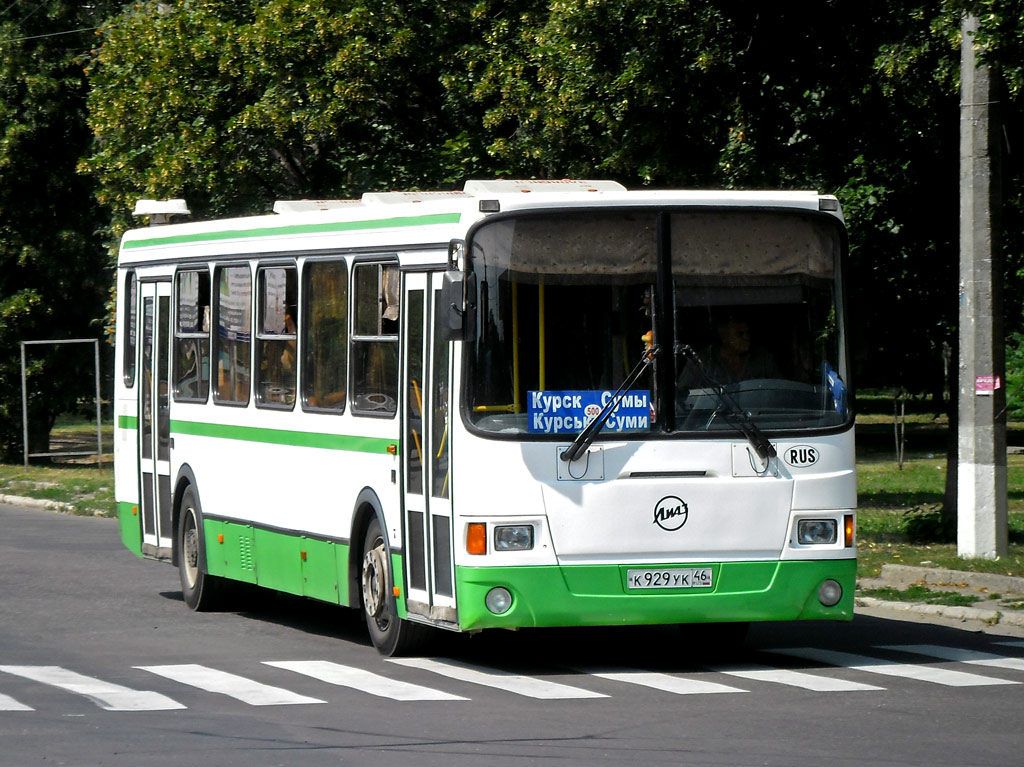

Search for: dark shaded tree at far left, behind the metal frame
xmin=0 ymin=2 xmax=118 ymax=456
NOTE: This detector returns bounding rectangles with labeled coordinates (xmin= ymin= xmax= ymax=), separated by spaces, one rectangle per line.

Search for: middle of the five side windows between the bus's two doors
xmin=255 ymin=266 xmax=298 ymax=410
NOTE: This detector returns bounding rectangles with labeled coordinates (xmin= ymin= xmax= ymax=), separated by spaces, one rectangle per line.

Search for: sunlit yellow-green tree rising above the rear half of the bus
xmin=83 ymin=0 xmax=479 ymax=225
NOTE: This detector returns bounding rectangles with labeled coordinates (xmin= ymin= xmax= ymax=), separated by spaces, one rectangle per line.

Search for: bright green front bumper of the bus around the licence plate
xmin=456 ymin=559 xmax=857 ymax=631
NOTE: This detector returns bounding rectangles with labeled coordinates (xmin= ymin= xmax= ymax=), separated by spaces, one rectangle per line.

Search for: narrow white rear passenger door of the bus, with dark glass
xmin=138 ymin=283 xmax=174 ymax=559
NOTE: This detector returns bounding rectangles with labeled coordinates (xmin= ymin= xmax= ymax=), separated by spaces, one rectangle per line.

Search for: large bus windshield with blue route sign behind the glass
xmin=464 ymin=208 xmax=850 ymax=439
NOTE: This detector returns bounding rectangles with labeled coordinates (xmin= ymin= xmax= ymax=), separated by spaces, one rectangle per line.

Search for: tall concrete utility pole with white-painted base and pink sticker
xmin=956 ymin=15 xmax=1007 ymax=559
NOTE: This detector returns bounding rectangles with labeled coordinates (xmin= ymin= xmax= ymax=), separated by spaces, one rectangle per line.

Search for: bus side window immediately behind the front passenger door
xmin=351 ymin=263 xmax=399 ymax=416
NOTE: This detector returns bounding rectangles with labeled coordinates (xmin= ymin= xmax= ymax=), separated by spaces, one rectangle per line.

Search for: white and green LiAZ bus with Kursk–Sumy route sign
xmin=116 ymin=180 xmax=856 ymax=654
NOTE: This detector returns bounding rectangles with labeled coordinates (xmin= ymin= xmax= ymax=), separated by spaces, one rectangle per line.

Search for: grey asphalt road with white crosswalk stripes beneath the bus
xmin=0 ymin=507 xmax=1024 ymax=767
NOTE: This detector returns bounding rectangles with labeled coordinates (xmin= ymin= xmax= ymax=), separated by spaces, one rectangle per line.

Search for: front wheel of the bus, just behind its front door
xmin=359 ymin=517 xmax=430 ymax=657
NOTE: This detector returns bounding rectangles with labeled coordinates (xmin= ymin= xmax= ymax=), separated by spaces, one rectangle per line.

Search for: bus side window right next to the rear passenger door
xmin=174 ymin=269 xmax=210 ymax=402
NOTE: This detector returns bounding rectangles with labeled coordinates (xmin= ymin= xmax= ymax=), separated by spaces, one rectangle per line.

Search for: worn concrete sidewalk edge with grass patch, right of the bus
xmin=856 ymin=564 xmax=1024 ymax=630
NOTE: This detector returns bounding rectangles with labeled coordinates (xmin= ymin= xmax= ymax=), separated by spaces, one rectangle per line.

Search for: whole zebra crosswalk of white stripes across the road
xmin=0 ymin=642 xmax=1024 ymax=715
